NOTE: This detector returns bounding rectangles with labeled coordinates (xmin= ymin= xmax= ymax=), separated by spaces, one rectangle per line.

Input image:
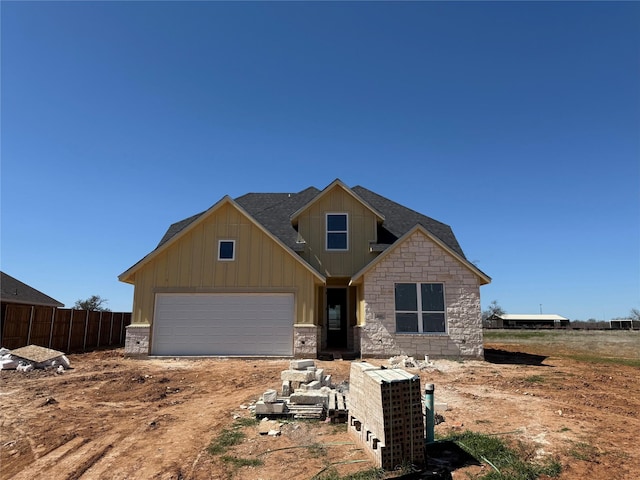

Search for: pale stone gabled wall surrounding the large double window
xmin=354 ymin=231 xmax=484 ymax=359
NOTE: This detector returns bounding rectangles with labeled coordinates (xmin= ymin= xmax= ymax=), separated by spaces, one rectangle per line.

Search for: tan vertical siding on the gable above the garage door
xmin=132 ymin=204 xmax=315 ymax=325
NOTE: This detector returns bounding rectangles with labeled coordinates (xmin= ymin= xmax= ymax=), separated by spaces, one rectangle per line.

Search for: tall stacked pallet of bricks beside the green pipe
xmin=349 ymin=362 xmax=425 ymax=470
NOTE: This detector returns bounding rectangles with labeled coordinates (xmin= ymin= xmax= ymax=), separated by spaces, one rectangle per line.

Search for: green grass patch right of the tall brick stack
xmin=440 ymin=431 xmax=562 ymax=480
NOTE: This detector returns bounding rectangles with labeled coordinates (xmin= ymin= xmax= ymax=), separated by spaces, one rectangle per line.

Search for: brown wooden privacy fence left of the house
xmin=0 ymin=304 xmax=131 ymax=352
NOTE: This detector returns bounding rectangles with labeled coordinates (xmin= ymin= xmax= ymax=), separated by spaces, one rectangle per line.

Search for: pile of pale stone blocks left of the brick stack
xmin=252 ymin=360 xmax=347 ymax=423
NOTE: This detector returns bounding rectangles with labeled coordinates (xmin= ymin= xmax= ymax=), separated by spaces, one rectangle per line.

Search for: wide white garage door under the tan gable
xmin=151 ymin=293 xmax=293 ymax=356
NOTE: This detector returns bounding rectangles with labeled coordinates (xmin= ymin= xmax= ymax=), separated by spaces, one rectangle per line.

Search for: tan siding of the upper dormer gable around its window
xmin=298 ymin=187 xmax=377 ymax=277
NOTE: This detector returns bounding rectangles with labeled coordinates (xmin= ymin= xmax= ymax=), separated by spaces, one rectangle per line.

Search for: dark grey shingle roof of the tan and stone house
xmin=156 ymin=180 xmax=466 ymax=260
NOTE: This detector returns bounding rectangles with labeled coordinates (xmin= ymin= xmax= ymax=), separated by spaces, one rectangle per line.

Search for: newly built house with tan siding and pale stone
xmin=119 ymin=180 xmax=491 ymax=358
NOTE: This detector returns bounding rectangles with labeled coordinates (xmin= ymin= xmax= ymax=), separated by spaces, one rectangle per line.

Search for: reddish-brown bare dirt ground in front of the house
xmin=0 ymin=344 xmax=640 ymax=480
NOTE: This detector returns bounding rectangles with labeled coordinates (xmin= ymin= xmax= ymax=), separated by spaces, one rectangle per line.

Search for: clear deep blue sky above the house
xmin=0 ymin=1 xmax=640 ymax=319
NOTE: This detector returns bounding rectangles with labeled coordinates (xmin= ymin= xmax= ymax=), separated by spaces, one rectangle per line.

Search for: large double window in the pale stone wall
xmin=395 ymin=283 xmax=446 ymax=333
